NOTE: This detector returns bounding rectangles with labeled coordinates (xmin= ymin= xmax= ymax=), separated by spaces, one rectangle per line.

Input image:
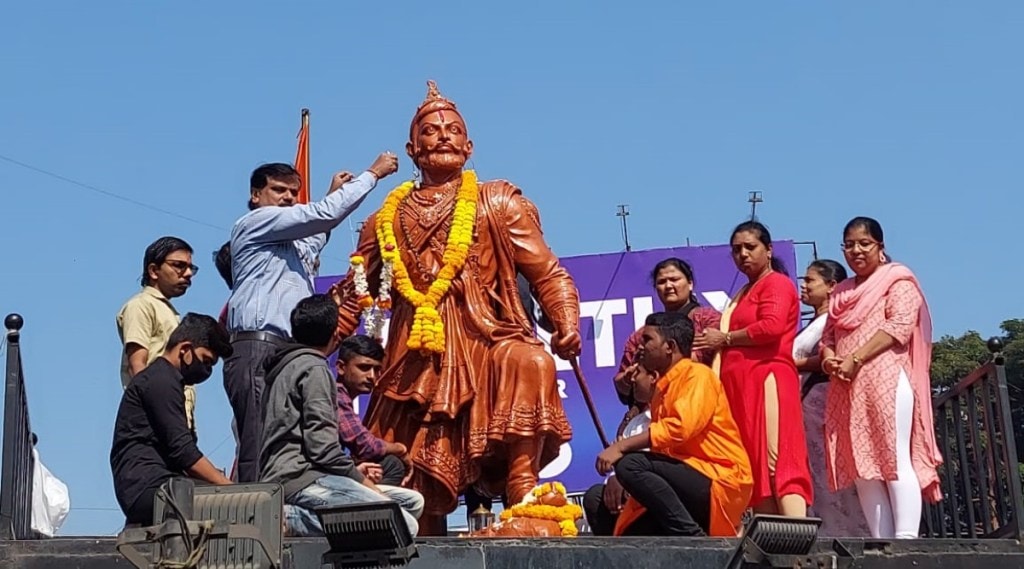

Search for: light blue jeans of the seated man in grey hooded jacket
xmin=285 ymin=475 xmax=424 ymax=537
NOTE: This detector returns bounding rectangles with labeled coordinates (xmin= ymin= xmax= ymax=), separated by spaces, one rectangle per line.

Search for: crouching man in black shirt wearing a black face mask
xmin=111 ymin=313 xmax=231 ymax=525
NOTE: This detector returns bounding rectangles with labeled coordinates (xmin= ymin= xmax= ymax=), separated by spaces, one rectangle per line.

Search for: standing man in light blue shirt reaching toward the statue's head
xmin=224 ymin=152 xmax=398 ymax=483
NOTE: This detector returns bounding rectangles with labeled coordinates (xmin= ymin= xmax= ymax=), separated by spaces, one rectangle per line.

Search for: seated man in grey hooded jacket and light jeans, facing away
xmin=259 ymin=295 xmax=423 ymax=535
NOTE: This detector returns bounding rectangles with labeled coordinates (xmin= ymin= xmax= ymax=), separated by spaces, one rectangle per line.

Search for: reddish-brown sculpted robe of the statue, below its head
xmin=332 ymin=181 xmax=580 ymax=516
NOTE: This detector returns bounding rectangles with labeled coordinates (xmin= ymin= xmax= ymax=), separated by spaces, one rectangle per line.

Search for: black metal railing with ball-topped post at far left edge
xmin=0 ymin=314 xmax=36 ymax=539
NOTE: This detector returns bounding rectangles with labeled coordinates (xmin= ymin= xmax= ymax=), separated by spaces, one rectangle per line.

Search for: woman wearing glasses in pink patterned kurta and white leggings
xmin=821 ymin=217 xmax=942 ymax=538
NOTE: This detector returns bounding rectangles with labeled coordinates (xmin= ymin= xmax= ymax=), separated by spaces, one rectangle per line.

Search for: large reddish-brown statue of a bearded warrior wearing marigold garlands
xmin=332 ymin=81 xmax=581 ymax=531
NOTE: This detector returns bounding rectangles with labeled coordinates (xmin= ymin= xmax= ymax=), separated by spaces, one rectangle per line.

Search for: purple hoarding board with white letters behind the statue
xmin=316 ymin=242 xmax=798 ymax=492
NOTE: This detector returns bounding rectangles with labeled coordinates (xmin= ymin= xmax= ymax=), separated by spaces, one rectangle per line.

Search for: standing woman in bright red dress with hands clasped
xmin=693 ymin=221 xmax=813 ymax=518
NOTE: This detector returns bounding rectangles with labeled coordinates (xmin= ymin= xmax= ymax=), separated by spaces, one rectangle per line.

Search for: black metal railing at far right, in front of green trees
xmin=922 ymin=338 xmax=1024 ymax=539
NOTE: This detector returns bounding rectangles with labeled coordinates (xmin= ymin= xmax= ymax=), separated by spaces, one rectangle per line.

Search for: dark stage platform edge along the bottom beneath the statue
xmin=0 ymin=537 xmax=1024 ymax=569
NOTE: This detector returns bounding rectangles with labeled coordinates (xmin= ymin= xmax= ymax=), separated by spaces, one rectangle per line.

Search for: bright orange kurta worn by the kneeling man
xmin=615 ymin=359 xmax=754 ymax=537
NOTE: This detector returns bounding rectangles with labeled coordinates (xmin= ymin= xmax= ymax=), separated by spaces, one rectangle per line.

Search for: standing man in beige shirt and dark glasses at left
xmin=117 ymin=237 xmax=199 ymax=429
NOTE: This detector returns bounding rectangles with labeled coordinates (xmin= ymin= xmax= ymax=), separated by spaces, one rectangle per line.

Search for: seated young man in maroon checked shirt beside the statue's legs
xmin=338 ymin=335 xmax=410 ymax=486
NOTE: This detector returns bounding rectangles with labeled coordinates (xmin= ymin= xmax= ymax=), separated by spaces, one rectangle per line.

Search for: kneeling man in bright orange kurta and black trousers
xmin=597 ymin=312 xmax=754 ymax=536
